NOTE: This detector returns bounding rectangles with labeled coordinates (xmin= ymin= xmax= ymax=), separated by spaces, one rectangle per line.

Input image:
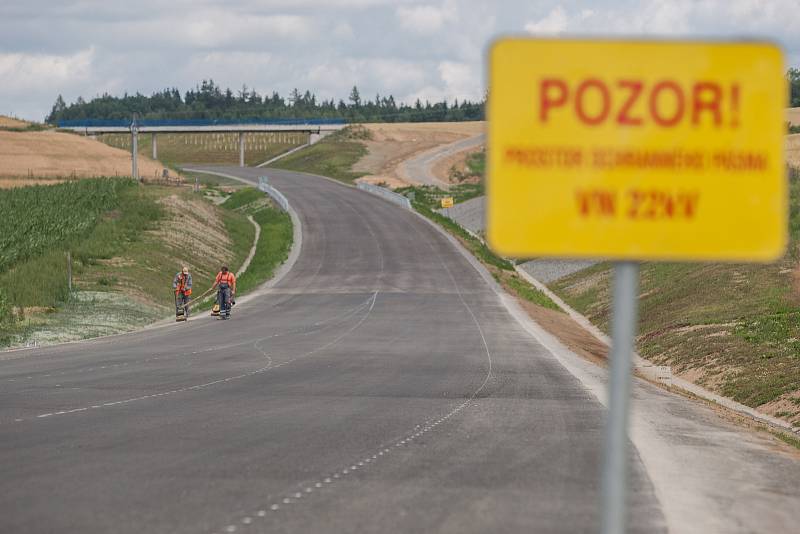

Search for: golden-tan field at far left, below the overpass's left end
xmin=0 ymin=131 xmax=174 ymax=186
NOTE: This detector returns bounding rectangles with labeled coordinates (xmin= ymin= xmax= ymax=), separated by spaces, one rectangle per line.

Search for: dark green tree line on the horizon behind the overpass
xmin=45 ymin=80 xmax=484 ymax=124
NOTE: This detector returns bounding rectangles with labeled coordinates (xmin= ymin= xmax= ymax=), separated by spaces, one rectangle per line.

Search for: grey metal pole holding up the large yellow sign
xmin=601 ymin=262 xmax=639 ymax=534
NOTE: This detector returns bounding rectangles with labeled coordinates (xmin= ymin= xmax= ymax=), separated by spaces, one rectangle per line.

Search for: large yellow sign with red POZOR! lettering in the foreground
xmin=487 ymin=39 xmax=788 ymax=261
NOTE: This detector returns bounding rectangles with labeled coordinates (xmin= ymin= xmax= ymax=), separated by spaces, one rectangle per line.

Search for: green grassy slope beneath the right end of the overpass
xmin=270 ymin=126 xmax=371 ymax=184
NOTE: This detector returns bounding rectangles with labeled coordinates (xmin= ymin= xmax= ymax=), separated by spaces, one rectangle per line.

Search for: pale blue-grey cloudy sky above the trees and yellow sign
xmin=0 ymin=0 xmax=800 ymax=120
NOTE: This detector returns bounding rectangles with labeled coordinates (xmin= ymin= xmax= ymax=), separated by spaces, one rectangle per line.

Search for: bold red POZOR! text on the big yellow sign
xmin=538 ymin=78 xmax=739 ymax=128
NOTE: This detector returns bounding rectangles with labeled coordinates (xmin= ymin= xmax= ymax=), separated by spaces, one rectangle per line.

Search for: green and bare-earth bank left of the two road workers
xmin=0 ymin=178 xmax=270 ymax=345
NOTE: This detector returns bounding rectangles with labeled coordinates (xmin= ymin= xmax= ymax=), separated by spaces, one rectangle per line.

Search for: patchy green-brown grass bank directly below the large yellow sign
xmin=551 ymin=172 xmax=800 ymax=426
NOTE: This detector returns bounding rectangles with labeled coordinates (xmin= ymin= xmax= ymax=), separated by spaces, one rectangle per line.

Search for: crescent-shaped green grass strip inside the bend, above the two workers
xmin=222 ymin=187 xmax=292 ymax=295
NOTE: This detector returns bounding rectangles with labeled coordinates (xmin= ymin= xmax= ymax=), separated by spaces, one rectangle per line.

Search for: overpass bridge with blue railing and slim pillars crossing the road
xmin=57 ymin=119 xmax=347 ymax=179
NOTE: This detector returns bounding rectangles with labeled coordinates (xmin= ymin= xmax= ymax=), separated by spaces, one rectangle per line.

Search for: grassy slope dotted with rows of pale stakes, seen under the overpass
xmin=98 ymin=132 xmax=308 ymax=167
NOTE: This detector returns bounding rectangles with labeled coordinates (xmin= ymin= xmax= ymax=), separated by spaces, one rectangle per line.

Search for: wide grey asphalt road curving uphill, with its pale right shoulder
xmin=0 ymin=168 xmax=800 ymax=533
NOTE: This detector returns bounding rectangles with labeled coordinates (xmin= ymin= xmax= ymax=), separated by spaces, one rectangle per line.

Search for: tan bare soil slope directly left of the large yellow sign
xmin=353 ymin=122 xmax=485 ymax=187
